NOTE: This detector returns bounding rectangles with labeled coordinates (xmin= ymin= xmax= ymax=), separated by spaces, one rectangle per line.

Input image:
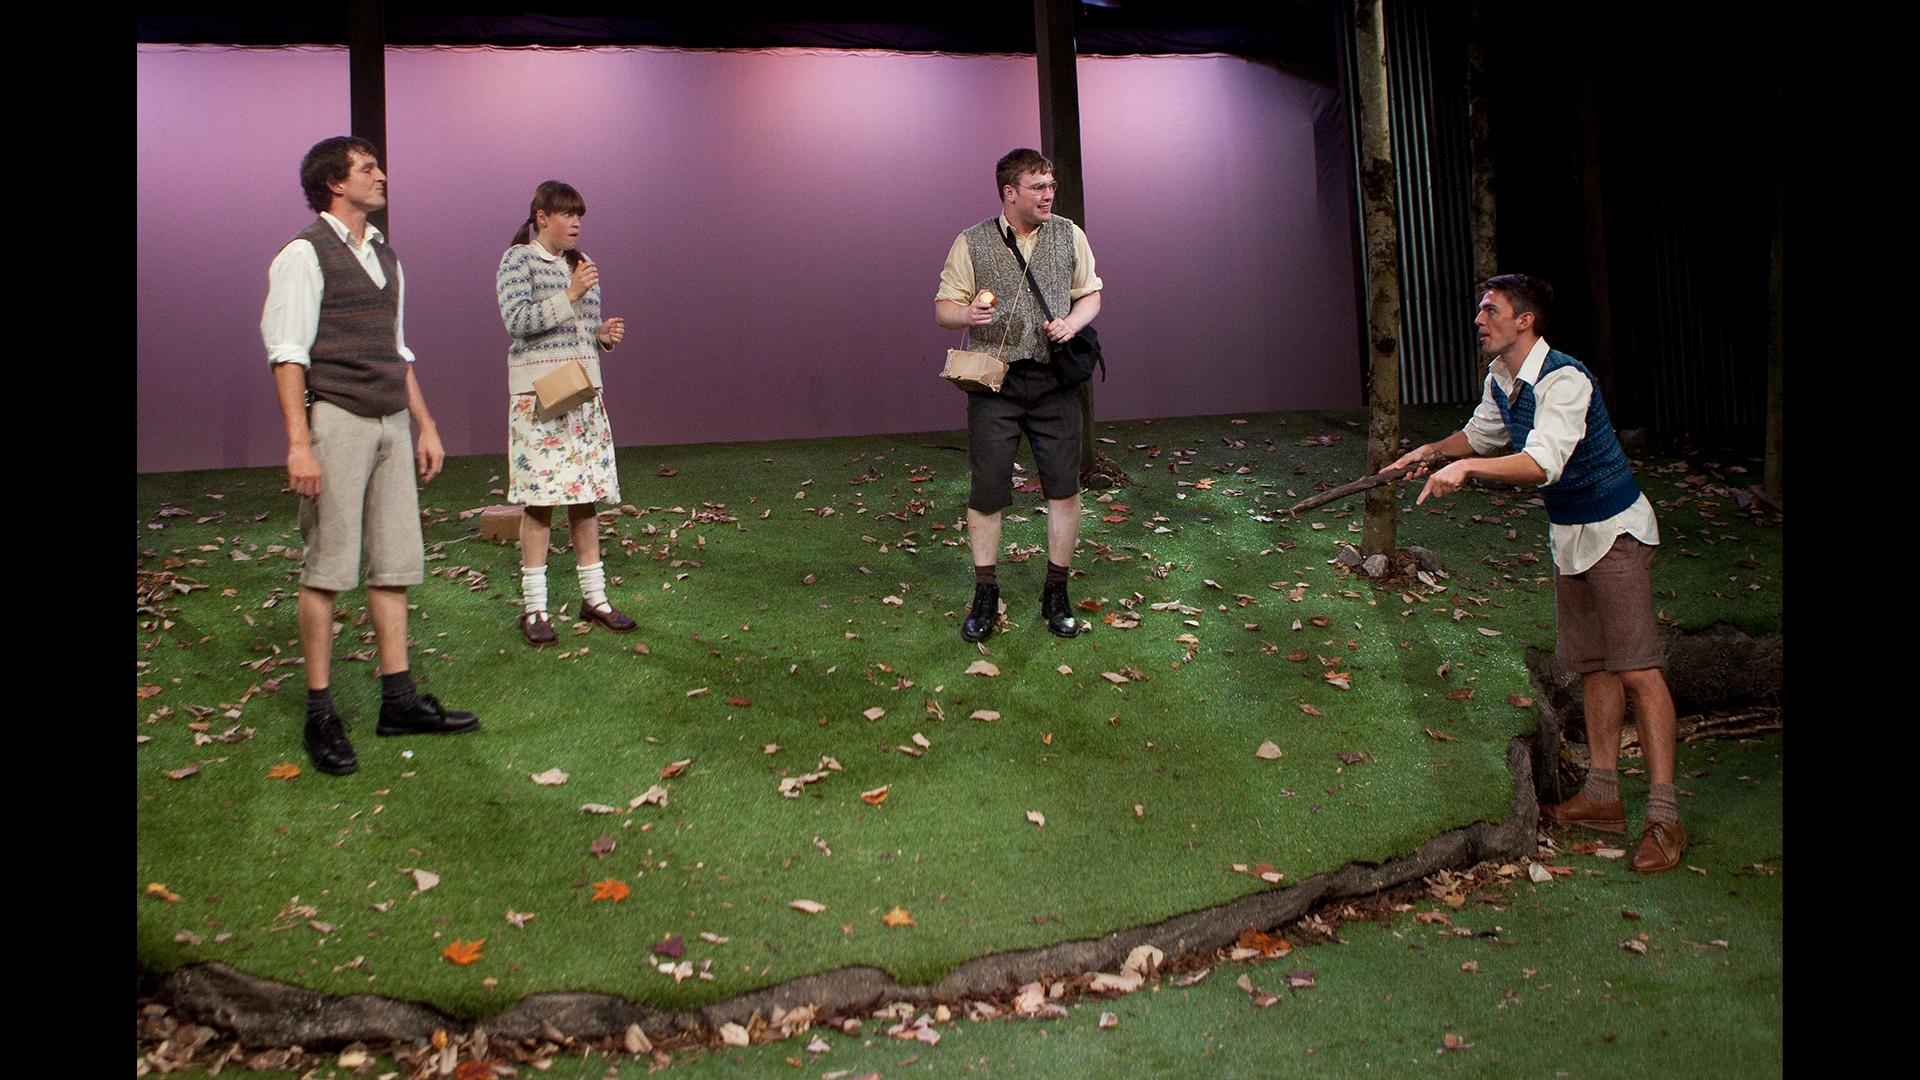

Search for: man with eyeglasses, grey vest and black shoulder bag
xmin=933 ymin=148 xmax=1100 ymax=642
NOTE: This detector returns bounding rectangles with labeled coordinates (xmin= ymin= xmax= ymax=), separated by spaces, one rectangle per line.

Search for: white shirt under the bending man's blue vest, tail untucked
xmin=1461 ymin=338 xmax=1661 ymax=575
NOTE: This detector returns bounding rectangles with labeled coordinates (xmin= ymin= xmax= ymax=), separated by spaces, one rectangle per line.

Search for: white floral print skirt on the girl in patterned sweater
xmin=507 ymin=394 xmax=620 ymax=505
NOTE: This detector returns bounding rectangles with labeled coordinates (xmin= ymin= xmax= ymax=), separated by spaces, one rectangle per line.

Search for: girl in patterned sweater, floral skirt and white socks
xmin=495 ymin=181 xmax=634 ymax=648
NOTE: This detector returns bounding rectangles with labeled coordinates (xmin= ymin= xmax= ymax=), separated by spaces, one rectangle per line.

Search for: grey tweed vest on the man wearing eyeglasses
xmin=962 ymin=213 xmax=1073 ymax=363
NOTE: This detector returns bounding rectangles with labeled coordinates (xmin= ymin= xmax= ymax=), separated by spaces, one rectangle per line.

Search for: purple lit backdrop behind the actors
xmin=136 ymin=46 xmax=1359 ymax=471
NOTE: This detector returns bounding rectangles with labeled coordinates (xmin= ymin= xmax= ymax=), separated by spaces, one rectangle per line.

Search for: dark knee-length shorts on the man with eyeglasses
xmin=966 ymin=359 xmax=1081 ymax=513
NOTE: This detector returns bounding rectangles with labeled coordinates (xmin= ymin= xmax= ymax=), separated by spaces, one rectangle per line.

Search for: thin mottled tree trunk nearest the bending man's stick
xmin=1354 ymin=0 xmax=1400 ymax=555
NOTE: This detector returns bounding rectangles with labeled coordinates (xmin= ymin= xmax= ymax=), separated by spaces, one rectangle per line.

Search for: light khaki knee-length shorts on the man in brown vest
xmin=300 ymin=402 xmax=424 ymax=592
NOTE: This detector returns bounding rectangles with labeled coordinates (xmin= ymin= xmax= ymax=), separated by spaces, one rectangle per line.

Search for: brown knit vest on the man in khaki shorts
xmin=294 ymin=221 xmax=407 ymax=417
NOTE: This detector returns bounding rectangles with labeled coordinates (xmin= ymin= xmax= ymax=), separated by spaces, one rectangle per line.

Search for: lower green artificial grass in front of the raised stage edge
xmin=149 ymin=736 xmax=1784 ymax=1080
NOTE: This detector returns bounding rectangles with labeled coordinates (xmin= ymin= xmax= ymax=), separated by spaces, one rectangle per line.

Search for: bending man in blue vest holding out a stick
xmin=1390 ymin=273 xmax=1686 ymax=872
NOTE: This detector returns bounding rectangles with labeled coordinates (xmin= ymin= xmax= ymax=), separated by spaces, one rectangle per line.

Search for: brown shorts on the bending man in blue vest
xmin=1553 ymin=532 xmax=1667 ymax=675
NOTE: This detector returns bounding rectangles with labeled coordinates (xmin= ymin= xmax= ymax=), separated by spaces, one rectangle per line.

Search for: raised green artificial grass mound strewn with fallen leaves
xmin=136 ymin=409 xmax=1780 ymax=1017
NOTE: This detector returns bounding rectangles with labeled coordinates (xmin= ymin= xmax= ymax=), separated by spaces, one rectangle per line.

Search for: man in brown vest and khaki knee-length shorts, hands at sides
xmin=259 ymin=136 xmax=480 ymax=774
